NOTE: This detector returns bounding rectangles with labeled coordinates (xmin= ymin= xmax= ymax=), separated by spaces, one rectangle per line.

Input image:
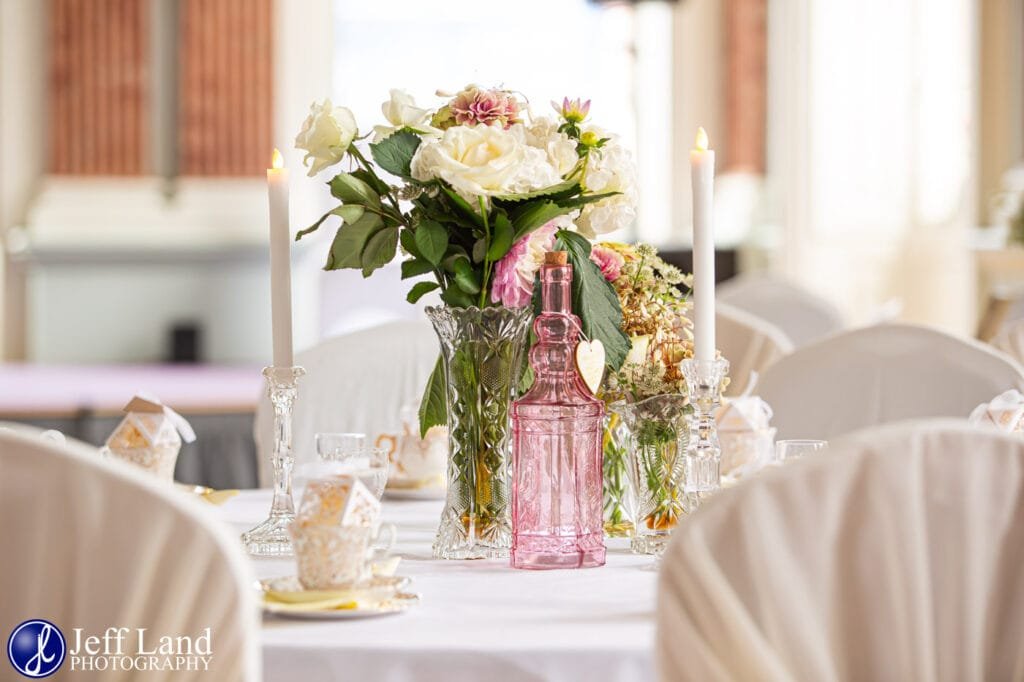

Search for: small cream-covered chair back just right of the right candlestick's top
xmin=715 ymin=303 xmax=793 ymax=395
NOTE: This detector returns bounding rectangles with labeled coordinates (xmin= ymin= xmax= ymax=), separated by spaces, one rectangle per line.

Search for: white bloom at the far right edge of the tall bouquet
xmin=577 ymin=133 xmax=637 ymax=239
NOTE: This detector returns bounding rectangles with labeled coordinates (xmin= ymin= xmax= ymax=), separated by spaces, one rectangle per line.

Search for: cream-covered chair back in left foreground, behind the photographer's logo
xmin=0 ymin=430 xmax=260 ymax=682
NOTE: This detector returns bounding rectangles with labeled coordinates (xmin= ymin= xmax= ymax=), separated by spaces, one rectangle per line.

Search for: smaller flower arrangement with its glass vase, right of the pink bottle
xmin=594 ymin=244 xmax=693 ymax=551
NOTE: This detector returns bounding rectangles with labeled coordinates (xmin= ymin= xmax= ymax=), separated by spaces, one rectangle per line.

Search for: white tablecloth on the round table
xmin=217 ymin=491 xmax=656 ymax=682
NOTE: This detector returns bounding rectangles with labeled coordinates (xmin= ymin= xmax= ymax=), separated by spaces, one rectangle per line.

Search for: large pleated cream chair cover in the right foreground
xmin=656 ymin=420 xmax=1024 ymax=682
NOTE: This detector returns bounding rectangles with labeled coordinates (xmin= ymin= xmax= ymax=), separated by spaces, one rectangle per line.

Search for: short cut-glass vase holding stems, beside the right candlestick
xmin=610 ymin=394 xmax=696 ymax=555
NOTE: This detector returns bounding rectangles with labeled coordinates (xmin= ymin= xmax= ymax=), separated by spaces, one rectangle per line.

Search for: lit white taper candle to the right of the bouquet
xmin=690 ymin=128 xmax=715 ymax=360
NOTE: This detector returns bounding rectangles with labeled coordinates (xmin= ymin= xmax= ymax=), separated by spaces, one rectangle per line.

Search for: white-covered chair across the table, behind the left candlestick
xmin=256 ymin=318 xmax=440 ymax=486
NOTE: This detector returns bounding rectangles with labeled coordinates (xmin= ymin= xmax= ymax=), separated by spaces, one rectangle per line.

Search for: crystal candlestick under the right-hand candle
xmin=680 ymin=359 xmax=729 ymax=494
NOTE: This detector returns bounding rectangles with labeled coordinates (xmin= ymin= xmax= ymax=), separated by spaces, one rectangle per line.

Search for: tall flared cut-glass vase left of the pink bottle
xmin=426 ymin=306 xmax=534 ymax=559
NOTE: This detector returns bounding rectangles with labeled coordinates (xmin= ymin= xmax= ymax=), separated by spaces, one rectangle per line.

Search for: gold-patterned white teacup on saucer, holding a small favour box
xmin=290 ymin=521 xmax=396 ymax=590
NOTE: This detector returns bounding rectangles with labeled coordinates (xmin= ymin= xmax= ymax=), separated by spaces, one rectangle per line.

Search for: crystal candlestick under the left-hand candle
xmin=242 ymin=367 xmax=306 ymax=556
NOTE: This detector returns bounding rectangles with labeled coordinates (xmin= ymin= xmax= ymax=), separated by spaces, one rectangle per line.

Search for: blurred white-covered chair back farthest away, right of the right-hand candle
xmin=716 ymin=272 xmax=844 ymax=348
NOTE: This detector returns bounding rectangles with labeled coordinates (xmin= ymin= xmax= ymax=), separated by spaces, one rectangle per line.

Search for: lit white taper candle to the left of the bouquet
xmin=266 ymin=150 xmax=295 ymax=367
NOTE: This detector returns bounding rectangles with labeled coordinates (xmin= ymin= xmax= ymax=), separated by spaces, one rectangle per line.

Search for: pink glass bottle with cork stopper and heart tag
xmin=511 ymin=252 xmax=605 ymax=568
